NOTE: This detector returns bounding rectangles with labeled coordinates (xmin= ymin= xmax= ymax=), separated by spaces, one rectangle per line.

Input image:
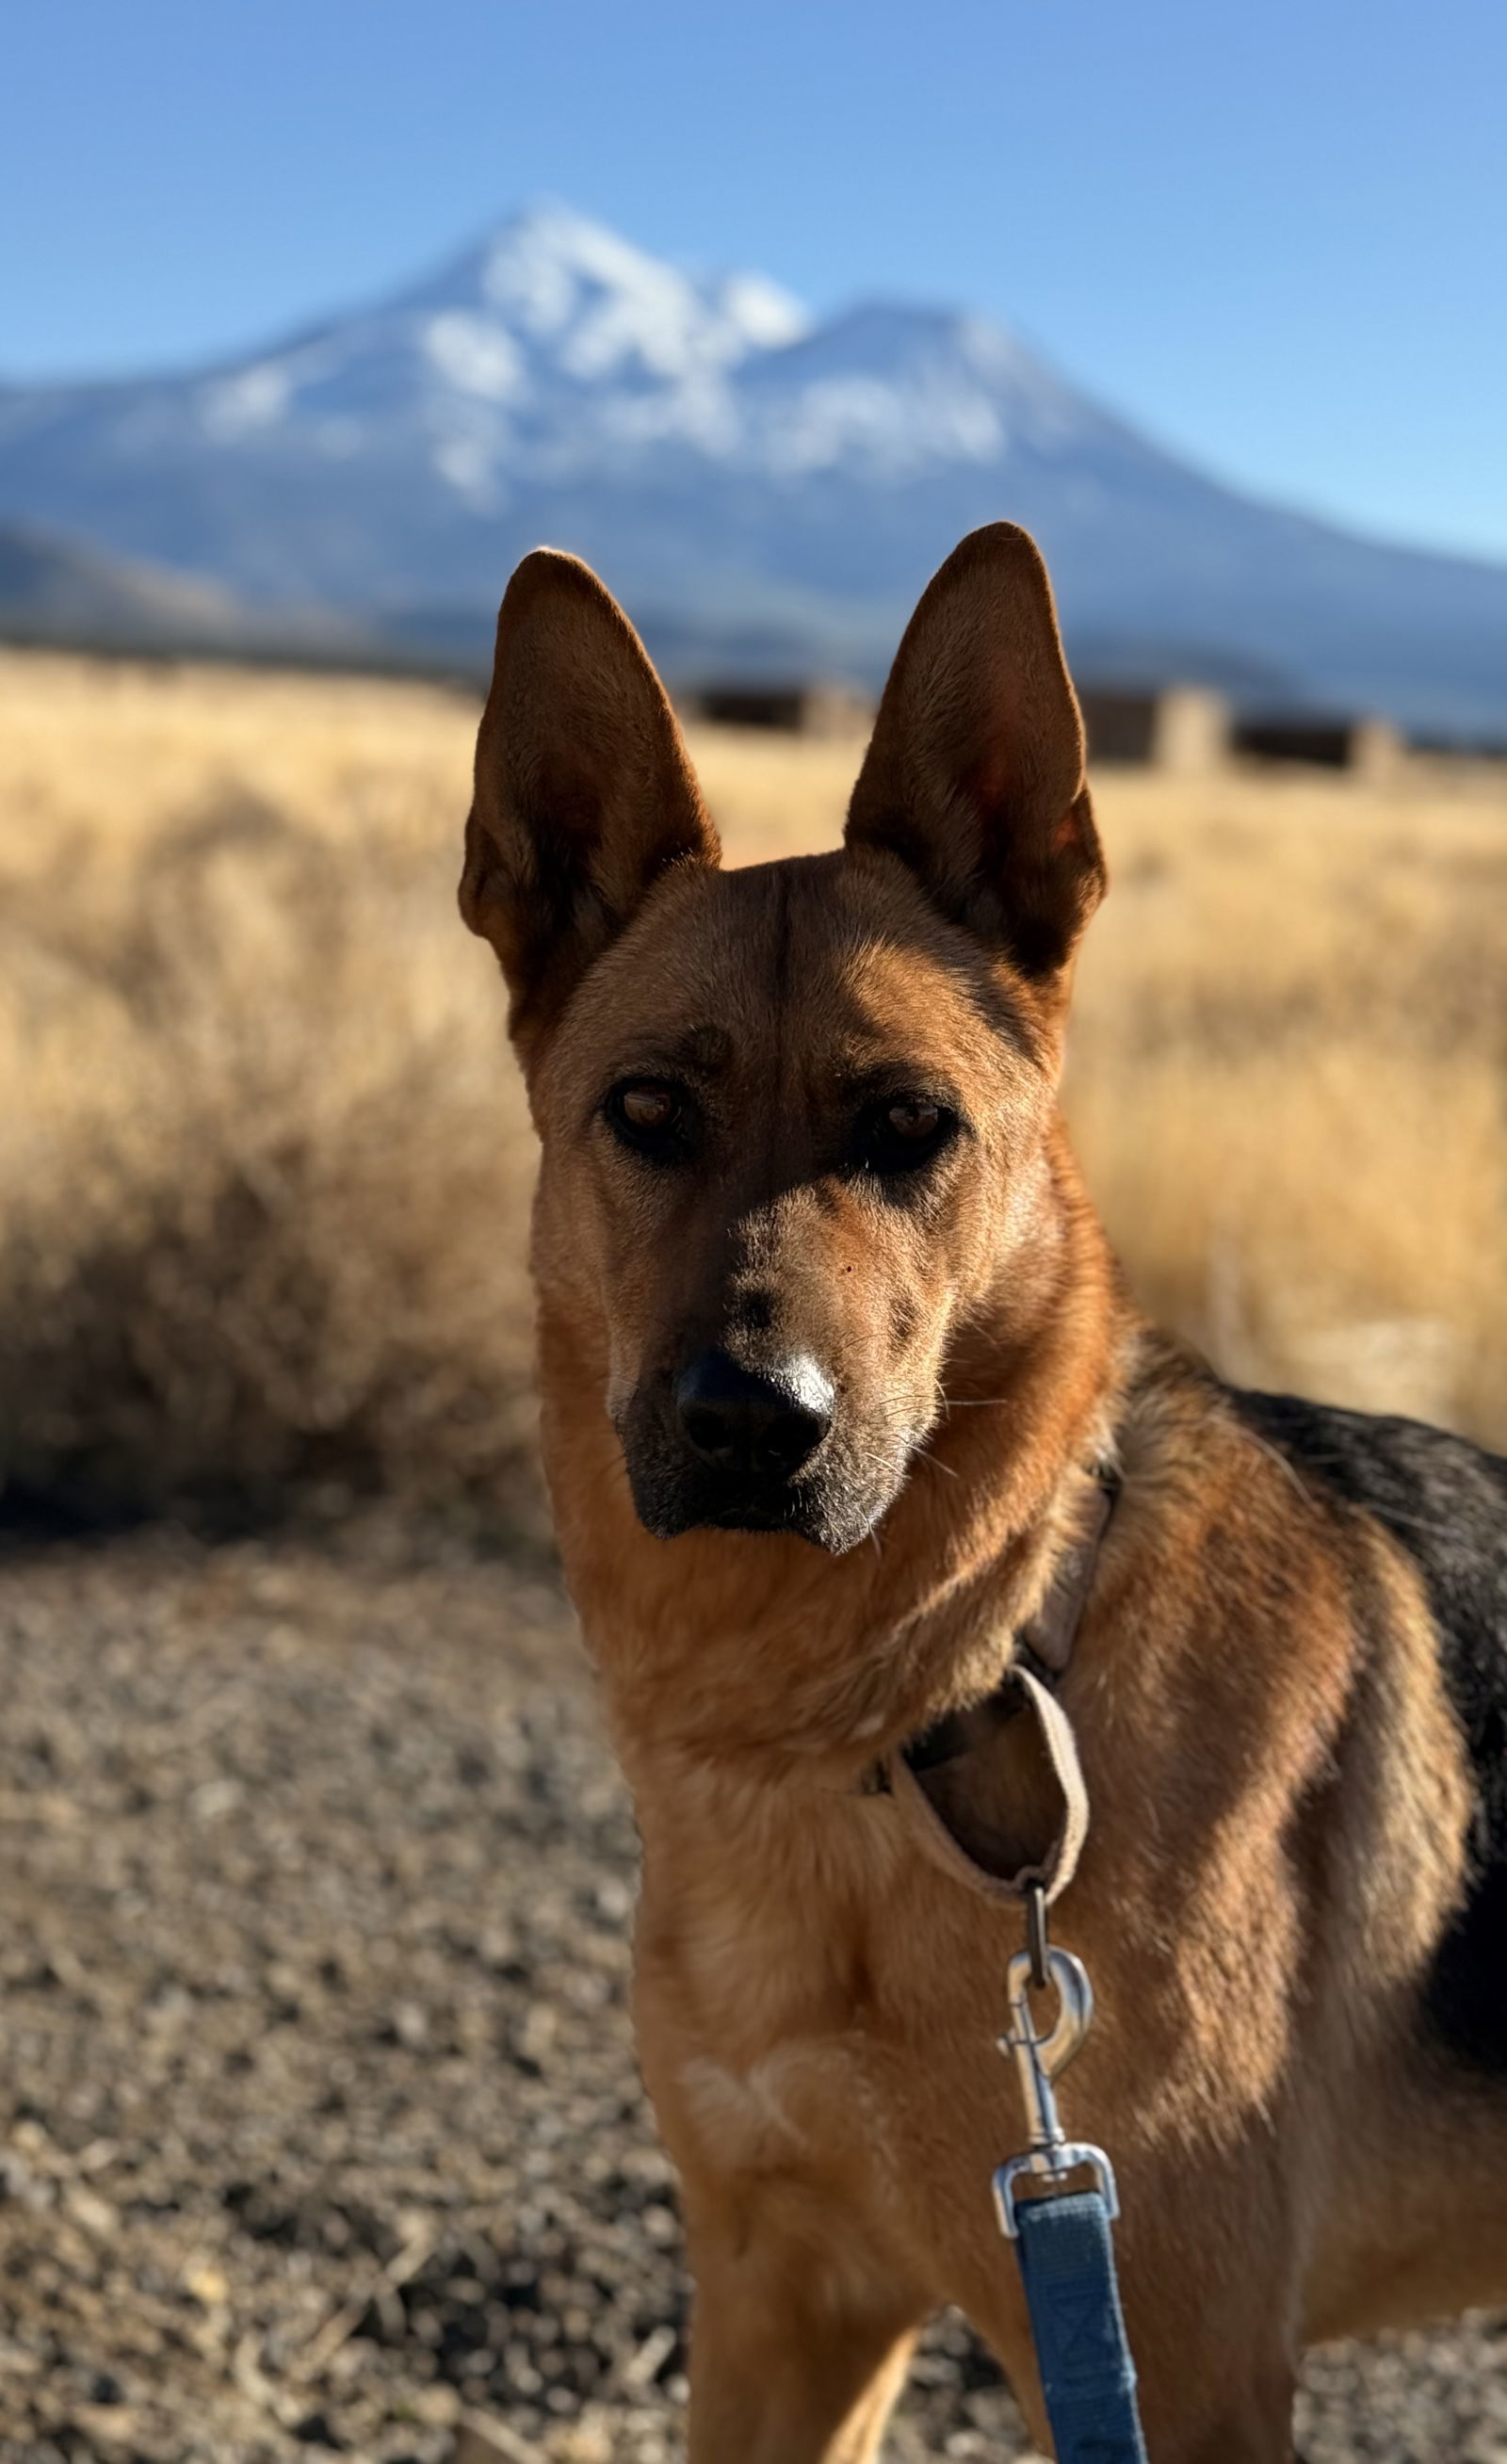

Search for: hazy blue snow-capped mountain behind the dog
xmin=0 ymin=207 xmax=1507 ymax=737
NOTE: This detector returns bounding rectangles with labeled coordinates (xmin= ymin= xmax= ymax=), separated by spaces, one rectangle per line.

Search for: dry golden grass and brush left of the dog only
xmin=0 ymin=660 xmax=542 ymax=1532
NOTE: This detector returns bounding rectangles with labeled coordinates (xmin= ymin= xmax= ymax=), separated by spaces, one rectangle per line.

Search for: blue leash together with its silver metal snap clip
xmin=995 ymin=1931 xmax=1147 ymax=2464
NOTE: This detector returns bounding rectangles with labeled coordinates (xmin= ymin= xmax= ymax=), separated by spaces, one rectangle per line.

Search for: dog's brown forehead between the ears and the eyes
xmin=572 ymin=855 xmax=1017 ymax=1077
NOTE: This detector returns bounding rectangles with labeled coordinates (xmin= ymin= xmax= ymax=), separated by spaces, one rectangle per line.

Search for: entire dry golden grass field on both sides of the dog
xmin=0 ymin=656 xmax=1507 ymax=1528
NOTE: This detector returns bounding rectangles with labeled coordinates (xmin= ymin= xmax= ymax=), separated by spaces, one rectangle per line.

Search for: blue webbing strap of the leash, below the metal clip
xmin=1014 ymin=2191 xmax=1147 ymax=2464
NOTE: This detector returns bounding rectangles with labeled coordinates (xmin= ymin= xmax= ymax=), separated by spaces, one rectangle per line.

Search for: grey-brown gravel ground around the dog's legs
xmin=0 ymin=1528 xmax=1507 ymax=2464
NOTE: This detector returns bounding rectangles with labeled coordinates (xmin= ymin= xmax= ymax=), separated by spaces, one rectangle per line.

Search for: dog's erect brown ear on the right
xmin=847 ymin=523 xmax=1106 ymax=976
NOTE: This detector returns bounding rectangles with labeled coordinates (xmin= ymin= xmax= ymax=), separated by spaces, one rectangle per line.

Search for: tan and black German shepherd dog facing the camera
xmin=461 ymin=523 xmax=1507 ymax=2464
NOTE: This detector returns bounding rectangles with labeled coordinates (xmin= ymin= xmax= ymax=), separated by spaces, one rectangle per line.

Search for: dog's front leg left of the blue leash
xmin=687 ymin=2208 xmax=929 ymax=2464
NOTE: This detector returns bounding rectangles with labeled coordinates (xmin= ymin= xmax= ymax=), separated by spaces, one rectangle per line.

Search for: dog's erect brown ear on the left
xmin=461 ymin=547 xmax=721 ymax=1040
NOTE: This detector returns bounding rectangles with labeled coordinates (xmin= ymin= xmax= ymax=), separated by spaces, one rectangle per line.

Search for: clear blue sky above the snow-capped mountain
xmin=0 ymin=0 xmax=1507 ymax=557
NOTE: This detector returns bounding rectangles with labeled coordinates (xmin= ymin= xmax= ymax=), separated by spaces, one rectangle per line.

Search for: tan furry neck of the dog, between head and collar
xmin=540 ymin=1141 xmax=1138 ymax=1784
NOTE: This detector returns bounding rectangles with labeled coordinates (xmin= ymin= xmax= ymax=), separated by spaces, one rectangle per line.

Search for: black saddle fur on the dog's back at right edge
xmin=1231 ymin=1392 xmax=1507 ymax=2075
